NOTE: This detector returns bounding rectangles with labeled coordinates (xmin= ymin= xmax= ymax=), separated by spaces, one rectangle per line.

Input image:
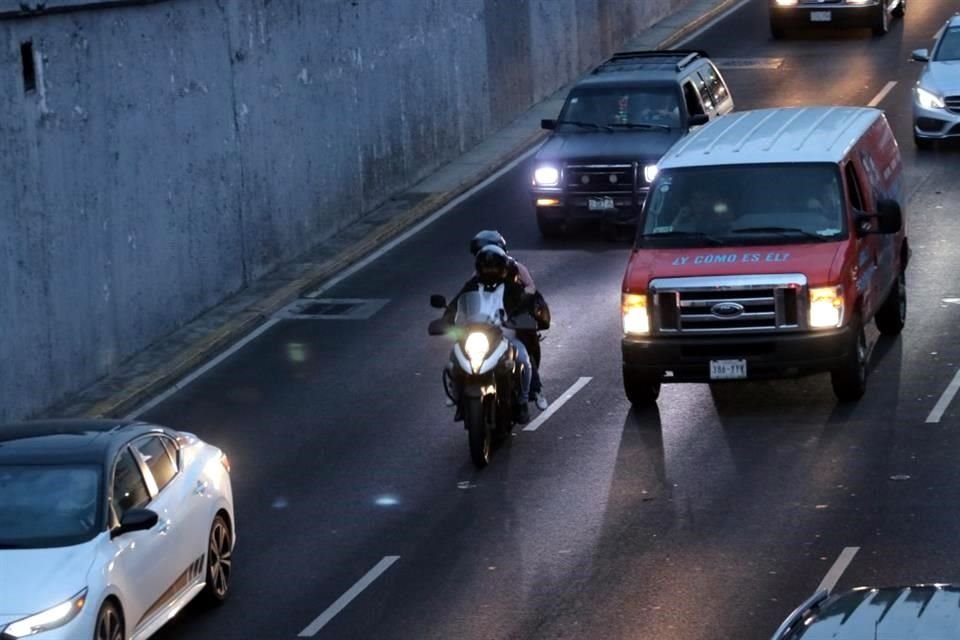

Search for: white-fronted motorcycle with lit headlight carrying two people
xmin=429 ymin=285 xmax=537 ymax=469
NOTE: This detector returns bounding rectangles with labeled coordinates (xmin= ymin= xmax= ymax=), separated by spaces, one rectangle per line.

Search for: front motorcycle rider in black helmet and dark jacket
xmin=443 ymin=244 xmax=533 ymax=424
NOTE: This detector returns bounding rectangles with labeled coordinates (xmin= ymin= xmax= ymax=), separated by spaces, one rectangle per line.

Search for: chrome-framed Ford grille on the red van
xmin=650 ymin=274 xmax=807 ymax=334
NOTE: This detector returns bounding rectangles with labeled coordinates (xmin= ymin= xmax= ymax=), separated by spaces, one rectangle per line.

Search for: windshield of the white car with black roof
xmin=0 ymin=465 xmax=101 ymax=549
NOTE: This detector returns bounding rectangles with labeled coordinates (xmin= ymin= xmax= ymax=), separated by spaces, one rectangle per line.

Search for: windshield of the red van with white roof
xmin=637 ymin=164 xmax=846 ymax=246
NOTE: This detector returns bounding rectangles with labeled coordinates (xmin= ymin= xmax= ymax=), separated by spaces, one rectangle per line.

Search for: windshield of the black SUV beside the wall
xmin=560 ymin=87 xmax=680 ymax=130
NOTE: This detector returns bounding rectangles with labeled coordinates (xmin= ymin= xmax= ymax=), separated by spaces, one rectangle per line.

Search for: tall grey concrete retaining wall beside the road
xmin=0 ymin=0 xmax=685 ymax=421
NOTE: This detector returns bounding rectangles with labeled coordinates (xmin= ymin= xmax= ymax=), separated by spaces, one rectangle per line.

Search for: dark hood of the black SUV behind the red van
xmin=537 ymin=129 xmax=683 ymax=164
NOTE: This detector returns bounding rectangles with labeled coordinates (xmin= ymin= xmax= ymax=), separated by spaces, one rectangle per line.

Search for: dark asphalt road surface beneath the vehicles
xmin=146 ymin=0 xmax=960 ymax=640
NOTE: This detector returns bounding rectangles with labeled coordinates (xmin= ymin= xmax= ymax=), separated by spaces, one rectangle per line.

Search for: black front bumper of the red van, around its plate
xmin=622 ymin=327 xmax=853 ymax=382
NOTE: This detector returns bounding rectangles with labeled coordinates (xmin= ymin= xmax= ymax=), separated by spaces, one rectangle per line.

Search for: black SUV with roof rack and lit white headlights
xmin=532 ymin=50 xmax=733 ymax=237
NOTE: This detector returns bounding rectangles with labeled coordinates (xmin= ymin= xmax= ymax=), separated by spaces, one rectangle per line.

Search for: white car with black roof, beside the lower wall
xmin=0 ymin=420 xmax=236 ymax=640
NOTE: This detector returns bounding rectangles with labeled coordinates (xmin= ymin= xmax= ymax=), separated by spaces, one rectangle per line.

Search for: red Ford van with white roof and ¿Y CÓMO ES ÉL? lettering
xmin=621 ymin=107 xmax=910 ymax=404
